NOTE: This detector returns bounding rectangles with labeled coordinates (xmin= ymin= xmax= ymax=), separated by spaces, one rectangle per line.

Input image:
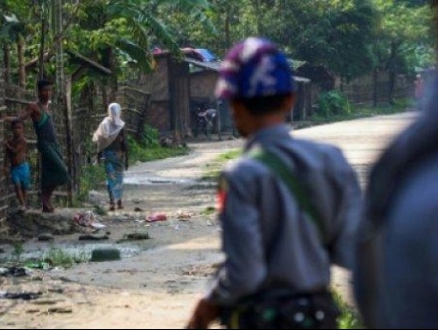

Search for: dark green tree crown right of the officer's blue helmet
xmin=292 ymin=0 xmax=378 ymax=80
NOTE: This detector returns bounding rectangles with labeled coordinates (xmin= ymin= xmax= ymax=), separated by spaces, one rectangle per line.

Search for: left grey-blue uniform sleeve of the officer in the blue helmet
xmin=207 ymin=164 xmax=266 ymax=305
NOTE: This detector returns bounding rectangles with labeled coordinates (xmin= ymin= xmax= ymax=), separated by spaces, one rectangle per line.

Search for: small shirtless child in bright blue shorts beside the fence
xmin=3 ymin=121 xmax=30 ymax=211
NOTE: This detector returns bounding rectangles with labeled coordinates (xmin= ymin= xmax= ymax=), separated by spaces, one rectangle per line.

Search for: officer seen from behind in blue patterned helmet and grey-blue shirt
xmin=187 ymin=37 xmax=361 ymax=328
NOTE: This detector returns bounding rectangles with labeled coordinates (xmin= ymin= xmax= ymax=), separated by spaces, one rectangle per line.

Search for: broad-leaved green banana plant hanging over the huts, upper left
xmin=66 ymin=0 xmax=209 ymax=72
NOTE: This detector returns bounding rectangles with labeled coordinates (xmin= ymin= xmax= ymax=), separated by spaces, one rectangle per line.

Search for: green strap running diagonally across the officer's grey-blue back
xmin=249 ymin=149 xmax=325 ymax=241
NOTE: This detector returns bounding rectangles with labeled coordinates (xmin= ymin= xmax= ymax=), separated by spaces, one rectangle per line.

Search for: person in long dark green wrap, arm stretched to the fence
xmin=5 ymin=79 xmax=71 ymax=213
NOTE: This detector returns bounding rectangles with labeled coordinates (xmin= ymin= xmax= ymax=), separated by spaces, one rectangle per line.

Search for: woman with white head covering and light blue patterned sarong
xmin=93 ymin=103 xmax=129 ymax=211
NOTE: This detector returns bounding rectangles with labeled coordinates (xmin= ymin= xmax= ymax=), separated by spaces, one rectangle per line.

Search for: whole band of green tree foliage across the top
xmin=0 ymin=0 xmax=434 ymax=98
